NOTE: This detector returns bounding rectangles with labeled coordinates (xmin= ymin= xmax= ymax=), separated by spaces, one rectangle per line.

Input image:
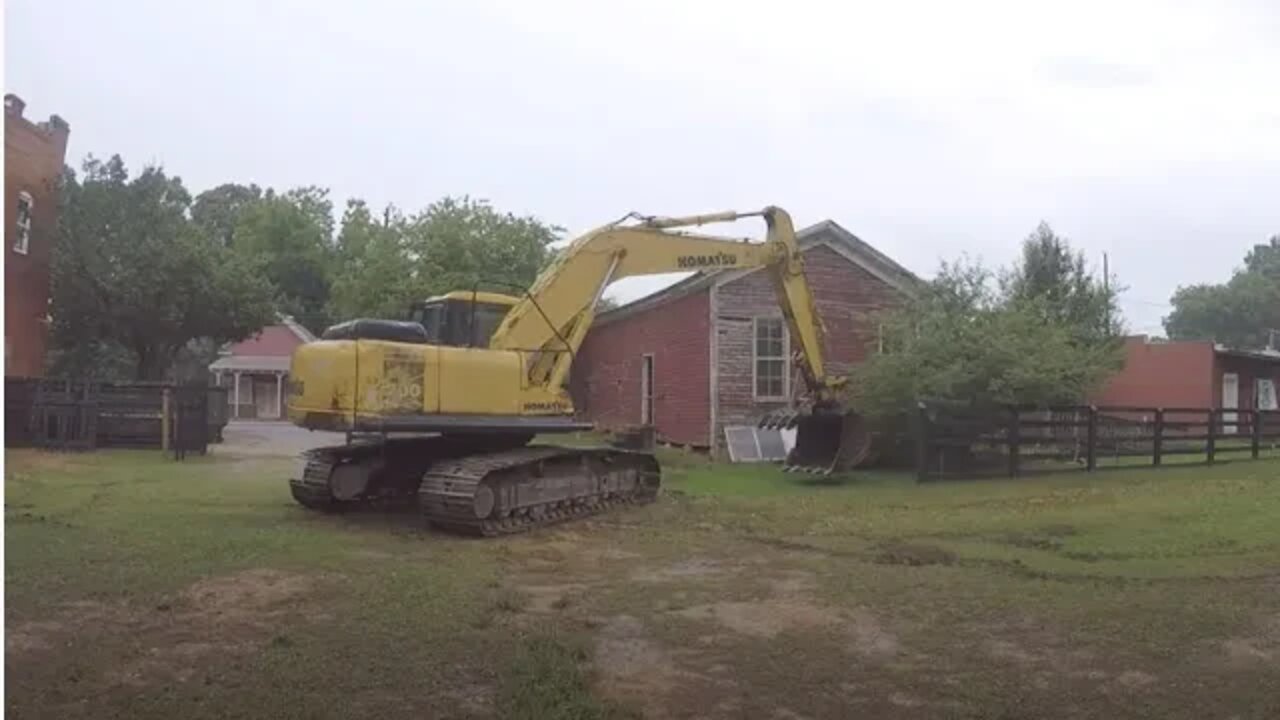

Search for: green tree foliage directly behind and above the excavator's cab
xmin=330 ymin=197 xmax=562 ymax=318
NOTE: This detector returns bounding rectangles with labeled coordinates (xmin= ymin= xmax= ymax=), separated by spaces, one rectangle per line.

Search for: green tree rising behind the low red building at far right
xmin=1165 ymin=236 xmax=1280 ymax=347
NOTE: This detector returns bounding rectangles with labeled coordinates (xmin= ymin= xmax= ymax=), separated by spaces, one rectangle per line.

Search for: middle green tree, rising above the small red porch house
xmin=232 ymin=187 xmax=334 ymax=332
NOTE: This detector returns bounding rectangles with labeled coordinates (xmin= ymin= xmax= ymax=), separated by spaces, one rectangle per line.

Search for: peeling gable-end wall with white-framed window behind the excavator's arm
xmin=716 ymin=245 xmax=901 ymax=446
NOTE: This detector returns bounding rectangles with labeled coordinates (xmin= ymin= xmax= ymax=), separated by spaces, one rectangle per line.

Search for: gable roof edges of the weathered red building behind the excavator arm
xmin=594 ymin=220 xmax=920 ymax=325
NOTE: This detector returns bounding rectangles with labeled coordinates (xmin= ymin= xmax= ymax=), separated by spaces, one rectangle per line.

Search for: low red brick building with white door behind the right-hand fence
xmin=1093 ymin=336 xmax=1280 ymax=425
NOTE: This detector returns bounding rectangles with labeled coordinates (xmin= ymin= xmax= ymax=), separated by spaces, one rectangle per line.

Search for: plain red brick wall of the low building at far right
xmin=1093 ymin=337 xmax=1222 ymax=407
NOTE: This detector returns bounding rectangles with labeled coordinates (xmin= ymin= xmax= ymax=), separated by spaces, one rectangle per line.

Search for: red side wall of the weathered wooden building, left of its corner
xmin=570 ymin=290 xmax=710 ymax=446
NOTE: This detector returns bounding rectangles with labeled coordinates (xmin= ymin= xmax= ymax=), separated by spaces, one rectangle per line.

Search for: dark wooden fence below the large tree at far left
xmin=5 ymin=378 xmax=227 ymax=457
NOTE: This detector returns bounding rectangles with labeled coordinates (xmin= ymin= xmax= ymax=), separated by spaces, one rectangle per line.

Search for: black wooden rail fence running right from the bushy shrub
xmin=915 ymin=404 xmax=1280 ymax=480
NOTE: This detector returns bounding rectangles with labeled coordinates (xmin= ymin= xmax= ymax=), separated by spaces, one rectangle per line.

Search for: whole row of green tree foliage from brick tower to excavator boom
xmin=50 ymin=151 xmax=562 ymax=379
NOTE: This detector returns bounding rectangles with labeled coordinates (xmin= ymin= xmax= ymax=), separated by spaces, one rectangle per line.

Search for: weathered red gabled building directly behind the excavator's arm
xmin=570 ymin=220 xmax=918 ymax=450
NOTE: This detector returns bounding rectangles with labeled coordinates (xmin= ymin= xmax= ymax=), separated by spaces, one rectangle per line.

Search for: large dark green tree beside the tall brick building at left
xmin=51 ymin=155 xmax=273 ymax=379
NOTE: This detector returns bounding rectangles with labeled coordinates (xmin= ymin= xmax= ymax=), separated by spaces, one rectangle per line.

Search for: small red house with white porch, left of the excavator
xmin=209 ymin=315 xmax=315 ymax=420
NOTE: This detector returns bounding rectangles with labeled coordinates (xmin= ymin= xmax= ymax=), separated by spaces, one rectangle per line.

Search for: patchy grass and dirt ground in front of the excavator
xmin=5 ymin=448 xmax=1280 ymax=720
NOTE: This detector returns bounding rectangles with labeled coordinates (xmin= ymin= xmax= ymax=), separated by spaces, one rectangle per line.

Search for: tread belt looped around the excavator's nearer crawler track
xmin=419 ymin=447 xmax=658 ymax=537
